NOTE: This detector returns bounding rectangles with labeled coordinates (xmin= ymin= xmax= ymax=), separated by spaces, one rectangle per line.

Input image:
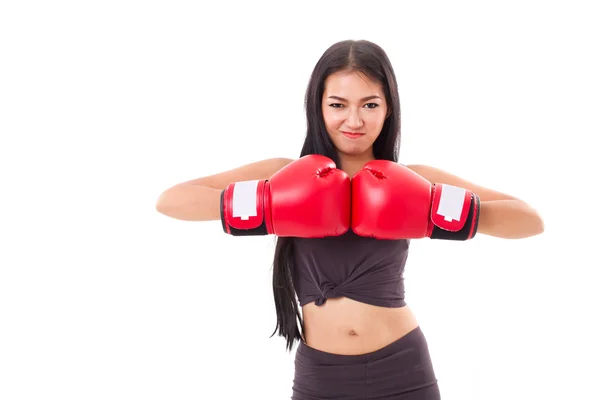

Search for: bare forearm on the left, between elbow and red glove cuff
xmin=156 ymin=183 xmax=222 ymax=221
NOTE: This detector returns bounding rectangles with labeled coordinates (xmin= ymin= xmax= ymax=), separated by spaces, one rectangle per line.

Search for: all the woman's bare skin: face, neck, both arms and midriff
xmin=156 ymin=71 xmax=544 ymax=354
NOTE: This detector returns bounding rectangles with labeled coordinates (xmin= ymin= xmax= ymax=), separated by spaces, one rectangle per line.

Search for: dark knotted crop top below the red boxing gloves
xmin=292 ymin=229 xmax=410 ymax=307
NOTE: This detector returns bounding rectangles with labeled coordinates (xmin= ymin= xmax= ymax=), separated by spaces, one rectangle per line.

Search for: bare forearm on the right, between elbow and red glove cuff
xmin=477 ymin=200 xmax=544 ymax=239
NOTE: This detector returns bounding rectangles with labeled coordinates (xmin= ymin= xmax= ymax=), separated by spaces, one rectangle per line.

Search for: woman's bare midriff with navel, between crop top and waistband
xmin=302 ymin=297 xmax=418 ymax=355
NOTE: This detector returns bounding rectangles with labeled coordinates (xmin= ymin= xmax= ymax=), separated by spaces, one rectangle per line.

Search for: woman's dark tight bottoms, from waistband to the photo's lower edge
xmin=291 ymin=327 xmax=440 ymax=400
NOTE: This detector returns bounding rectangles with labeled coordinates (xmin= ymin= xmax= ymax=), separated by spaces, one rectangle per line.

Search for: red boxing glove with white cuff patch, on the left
xmin=221 ymin=154 xmax=350 ymax=238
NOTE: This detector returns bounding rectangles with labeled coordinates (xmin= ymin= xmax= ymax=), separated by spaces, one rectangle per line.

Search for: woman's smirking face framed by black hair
xmin=321 ymin=71 xmax=388 ymax=157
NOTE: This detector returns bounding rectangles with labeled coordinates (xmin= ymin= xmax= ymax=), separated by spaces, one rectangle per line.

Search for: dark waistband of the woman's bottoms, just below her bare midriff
xmin=296 ymin=326 xmax=426 ymax=365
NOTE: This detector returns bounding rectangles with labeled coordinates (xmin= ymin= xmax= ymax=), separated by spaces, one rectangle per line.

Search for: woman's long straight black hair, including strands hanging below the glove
xmin=271 ymin=40 xmax=400 ymax=351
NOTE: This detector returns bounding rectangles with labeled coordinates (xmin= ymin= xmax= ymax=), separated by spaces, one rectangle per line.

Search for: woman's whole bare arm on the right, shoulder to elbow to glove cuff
xmin=407 ymin=165 xmax=544 ymax=239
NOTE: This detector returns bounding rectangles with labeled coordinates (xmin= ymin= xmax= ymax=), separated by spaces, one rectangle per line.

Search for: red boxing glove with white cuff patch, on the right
xmin=352 ymin=160 xmax=480 ymax=240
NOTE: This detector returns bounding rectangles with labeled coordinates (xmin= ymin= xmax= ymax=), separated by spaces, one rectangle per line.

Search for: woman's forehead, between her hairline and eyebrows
xmin=324 ymin=71 xmax=383 ymax=98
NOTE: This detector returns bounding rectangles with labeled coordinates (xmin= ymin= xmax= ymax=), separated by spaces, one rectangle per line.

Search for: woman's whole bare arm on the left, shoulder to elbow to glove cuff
xmin=156 ymin=158 xmax=293 ymax=221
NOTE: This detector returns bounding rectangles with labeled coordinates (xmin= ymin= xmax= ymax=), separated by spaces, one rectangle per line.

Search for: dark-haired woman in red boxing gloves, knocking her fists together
xmin=156 ymin=41 xmax=544 ymax=400
